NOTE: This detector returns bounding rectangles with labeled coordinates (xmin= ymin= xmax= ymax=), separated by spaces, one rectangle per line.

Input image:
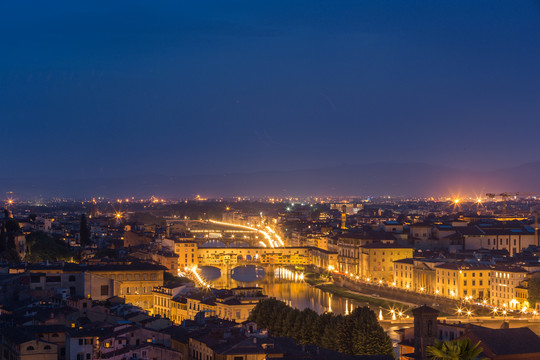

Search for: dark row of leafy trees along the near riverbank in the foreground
xmin=250 ymin=299 xmax=394 ymax=355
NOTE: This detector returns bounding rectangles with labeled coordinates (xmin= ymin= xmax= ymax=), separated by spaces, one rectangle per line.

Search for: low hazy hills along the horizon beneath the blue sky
xmin=0 ymin=161 xmax=540 ymax=198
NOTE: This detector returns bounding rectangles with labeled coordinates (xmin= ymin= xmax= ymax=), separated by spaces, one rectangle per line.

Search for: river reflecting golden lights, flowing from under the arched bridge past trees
xmin=200 ymin=266 xmax=399 ymax=342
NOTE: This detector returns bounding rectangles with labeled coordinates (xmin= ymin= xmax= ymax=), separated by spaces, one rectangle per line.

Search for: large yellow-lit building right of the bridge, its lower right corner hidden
xmin=360 ymin=242 xmax=413 ymax=284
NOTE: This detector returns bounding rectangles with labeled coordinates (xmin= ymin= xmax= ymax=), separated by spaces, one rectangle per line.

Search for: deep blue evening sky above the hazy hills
xmin=0 ymin=0 xmax=540 ymax=178
